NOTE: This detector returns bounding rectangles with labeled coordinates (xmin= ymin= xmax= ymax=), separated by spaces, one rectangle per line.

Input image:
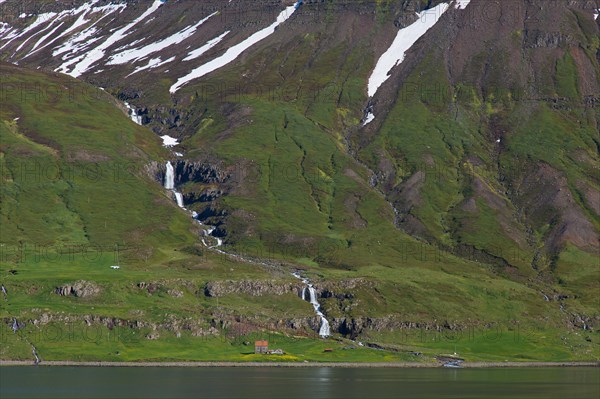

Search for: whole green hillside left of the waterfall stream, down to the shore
xmin=0 ymin=64 xmax=332 ymax=360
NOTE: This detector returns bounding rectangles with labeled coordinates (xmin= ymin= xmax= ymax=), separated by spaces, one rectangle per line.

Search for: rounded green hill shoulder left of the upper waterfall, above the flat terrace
xmin=1 ymin=64 xmax=194 ymax=253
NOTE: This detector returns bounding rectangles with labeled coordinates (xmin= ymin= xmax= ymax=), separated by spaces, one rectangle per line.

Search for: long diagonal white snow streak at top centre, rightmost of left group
xmin=169 ymin=5 xmax=296 ymax=93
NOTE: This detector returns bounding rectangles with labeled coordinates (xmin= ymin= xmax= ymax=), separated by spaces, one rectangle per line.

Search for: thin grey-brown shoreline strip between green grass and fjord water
xmin=0 ymin=360 xmax=600 ymax=368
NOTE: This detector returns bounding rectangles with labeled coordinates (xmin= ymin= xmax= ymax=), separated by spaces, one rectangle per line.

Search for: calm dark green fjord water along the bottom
xmin=0 ymin=367 xmax=600 ymax=399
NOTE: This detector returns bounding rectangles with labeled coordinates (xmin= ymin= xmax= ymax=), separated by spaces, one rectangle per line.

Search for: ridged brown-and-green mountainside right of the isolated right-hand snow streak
xmin=352 ymin=1 xmax=600 ymax=312
